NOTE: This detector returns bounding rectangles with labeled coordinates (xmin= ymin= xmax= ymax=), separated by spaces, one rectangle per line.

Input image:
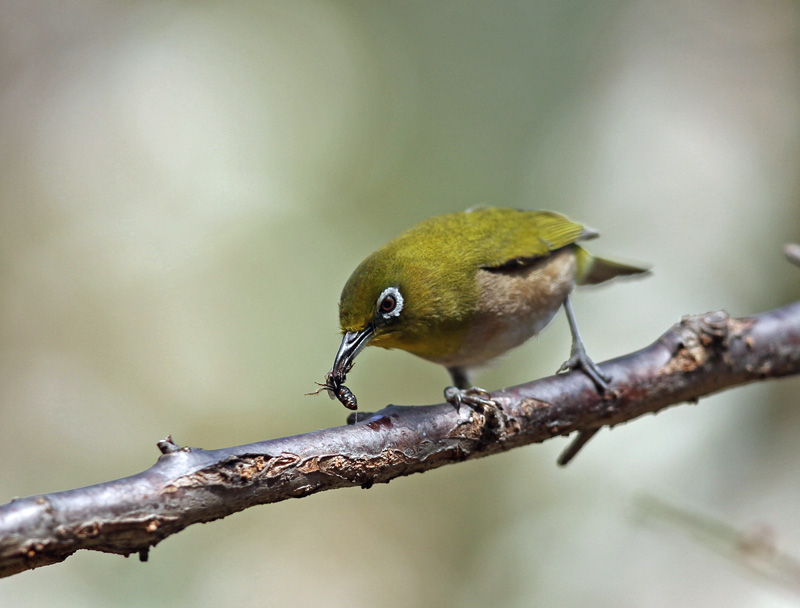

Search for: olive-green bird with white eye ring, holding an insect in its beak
xmin=317 ymin=207 xmax=649 ymax=465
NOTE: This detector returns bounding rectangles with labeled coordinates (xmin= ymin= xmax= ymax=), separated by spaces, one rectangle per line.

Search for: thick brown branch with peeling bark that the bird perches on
xmin=0 ymin=302 xmax=800 ymax=576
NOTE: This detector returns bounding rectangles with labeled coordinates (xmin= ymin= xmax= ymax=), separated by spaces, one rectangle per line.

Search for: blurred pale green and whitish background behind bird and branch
xmin=0 ymin=0 xmax=800 ymax=607
